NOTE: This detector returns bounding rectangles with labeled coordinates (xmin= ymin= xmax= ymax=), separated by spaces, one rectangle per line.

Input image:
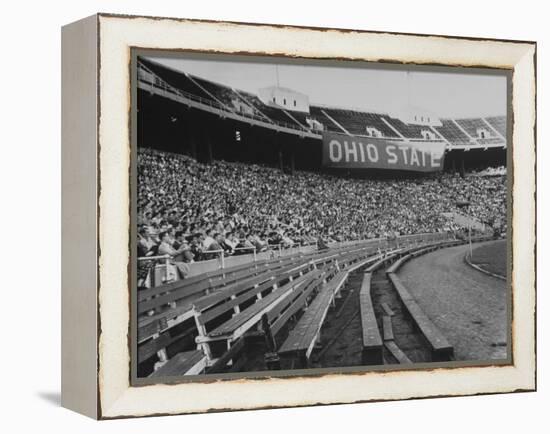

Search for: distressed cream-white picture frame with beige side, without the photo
xmin=62 ymin=14 xmax=536 ymax=419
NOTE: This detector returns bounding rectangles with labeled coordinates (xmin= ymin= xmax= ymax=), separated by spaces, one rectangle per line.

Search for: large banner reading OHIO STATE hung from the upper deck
xmin=323 ymin=132 xmax=445 ymax=172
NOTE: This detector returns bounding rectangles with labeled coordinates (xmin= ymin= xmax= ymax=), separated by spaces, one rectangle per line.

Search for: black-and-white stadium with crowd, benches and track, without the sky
xmin=135 ymin=57 xmax=509 ymax=379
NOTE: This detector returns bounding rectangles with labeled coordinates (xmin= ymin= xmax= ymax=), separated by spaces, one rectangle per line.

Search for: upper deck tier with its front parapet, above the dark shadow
xmin=138 ymin=58 xmax=506 ymax=150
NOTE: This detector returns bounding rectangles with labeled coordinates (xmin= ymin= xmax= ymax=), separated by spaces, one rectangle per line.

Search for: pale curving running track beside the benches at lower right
xmin=399 ymin=241 xmax=508 ymax=360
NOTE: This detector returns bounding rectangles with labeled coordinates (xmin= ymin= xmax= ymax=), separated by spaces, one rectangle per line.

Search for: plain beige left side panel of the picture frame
xmin=61 ymin=14 xmax=100 ymax=419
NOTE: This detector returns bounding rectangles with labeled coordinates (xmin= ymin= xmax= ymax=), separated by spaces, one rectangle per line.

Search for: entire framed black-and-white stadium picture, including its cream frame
xmin=62 ymin=14 xmax=536 ymax=419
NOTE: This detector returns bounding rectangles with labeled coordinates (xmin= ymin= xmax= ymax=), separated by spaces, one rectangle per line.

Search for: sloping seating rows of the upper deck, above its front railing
xmin=140 ymin=59 xmax=506 ymax=147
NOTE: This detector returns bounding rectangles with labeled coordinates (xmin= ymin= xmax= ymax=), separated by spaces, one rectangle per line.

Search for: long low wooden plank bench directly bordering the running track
xmin=388 ymin=273 xmax=454 ymax=361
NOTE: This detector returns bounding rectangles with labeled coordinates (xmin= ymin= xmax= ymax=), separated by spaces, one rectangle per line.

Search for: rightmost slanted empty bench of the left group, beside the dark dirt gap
xmin=278 ymin=271 xmax=348 ymax=364
